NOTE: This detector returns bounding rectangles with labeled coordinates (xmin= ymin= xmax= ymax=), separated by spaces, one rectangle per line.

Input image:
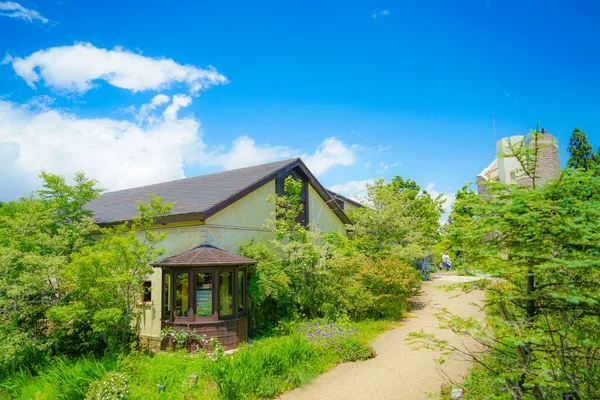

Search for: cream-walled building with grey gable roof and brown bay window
xmin=85 ymin=158 xmax=360 ymax=347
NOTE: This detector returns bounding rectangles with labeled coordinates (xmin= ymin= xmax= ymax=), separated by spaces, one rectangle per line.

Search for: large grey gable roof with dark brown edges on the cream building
xmin=84 ymin=158 xmax=351 ymax=224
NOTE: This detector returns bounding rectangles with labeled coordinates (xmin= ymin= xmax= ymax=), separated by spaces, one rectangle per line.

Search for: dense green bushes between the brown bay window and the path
xmin=241 ymin=236 xmax=421 ymax=338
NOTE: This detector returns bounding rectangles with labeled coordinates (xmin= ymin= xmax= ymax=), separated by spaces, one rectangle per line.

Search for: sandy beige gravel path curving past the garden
xmin=280 ymin=275 xmax=483 ymax=400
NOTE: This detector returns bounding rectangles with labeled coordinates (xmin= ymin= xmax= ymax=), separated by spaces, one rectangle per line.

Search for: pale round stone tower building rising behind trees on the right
xmin=477 ymin=128 xmax=560 ymax=194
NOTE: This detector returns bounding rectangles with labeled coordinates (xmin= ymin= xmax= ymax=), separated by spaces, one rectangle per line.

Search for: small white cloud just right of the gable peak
xmin=302 ymin=137 xmax=357 ymax=175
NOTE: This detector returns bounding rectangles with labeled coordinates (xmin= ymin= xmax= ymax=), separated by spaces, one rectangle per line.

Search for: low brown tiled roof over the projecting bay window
xmin=152 ymin=244 xmax=256 ymax=267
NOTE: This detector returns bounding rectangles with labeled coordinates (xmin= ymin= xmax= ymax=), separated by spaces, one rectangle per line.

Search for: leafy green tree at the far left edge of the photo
xmin=0 ymin=173 xmax=101 ymax=373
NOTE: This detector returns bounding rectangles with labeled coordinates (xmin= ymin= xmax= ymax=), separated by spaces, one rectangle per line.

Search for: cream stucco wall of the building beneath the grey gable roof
xmin=139 ymin=180 xmax=346 ymax=336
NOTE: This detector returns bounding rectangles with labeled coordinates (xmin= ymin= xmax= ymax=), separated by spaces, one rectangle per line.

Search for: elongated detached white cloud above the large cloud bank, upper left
xmin=12 ymin=43 xmax=228 ymax=94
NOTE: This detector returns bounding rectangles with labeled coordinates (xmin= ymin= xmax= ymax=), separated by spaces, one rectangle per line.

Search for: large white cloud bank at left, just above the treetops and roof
xmin=0 ymin=95 xmax=203 ymax=200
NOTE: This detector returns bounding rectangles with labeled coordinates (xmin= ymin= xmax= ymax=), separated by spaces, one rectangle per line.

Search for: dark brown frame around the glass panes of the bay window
xmin=161 ymin=265 xmax=248 ymax=324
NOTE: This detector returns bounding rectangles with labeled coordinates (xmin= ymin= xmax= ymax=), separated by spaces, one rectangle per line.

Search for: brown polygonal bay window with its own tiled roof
xmin=153 ymin=244 xmax=256 ymax=347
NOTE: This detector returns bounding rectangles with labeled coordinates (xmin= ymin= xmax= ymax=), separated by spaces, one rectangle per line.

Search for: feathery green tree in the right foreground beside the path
xmin=417 ymin=132 xmax=600 ymax=400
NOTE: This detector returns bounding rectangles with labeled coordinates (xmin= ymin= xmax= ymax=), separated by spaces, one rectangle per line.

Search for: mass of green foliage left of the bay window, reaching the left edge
xmin=0 ymin=173 xmax=170 ymax=377
